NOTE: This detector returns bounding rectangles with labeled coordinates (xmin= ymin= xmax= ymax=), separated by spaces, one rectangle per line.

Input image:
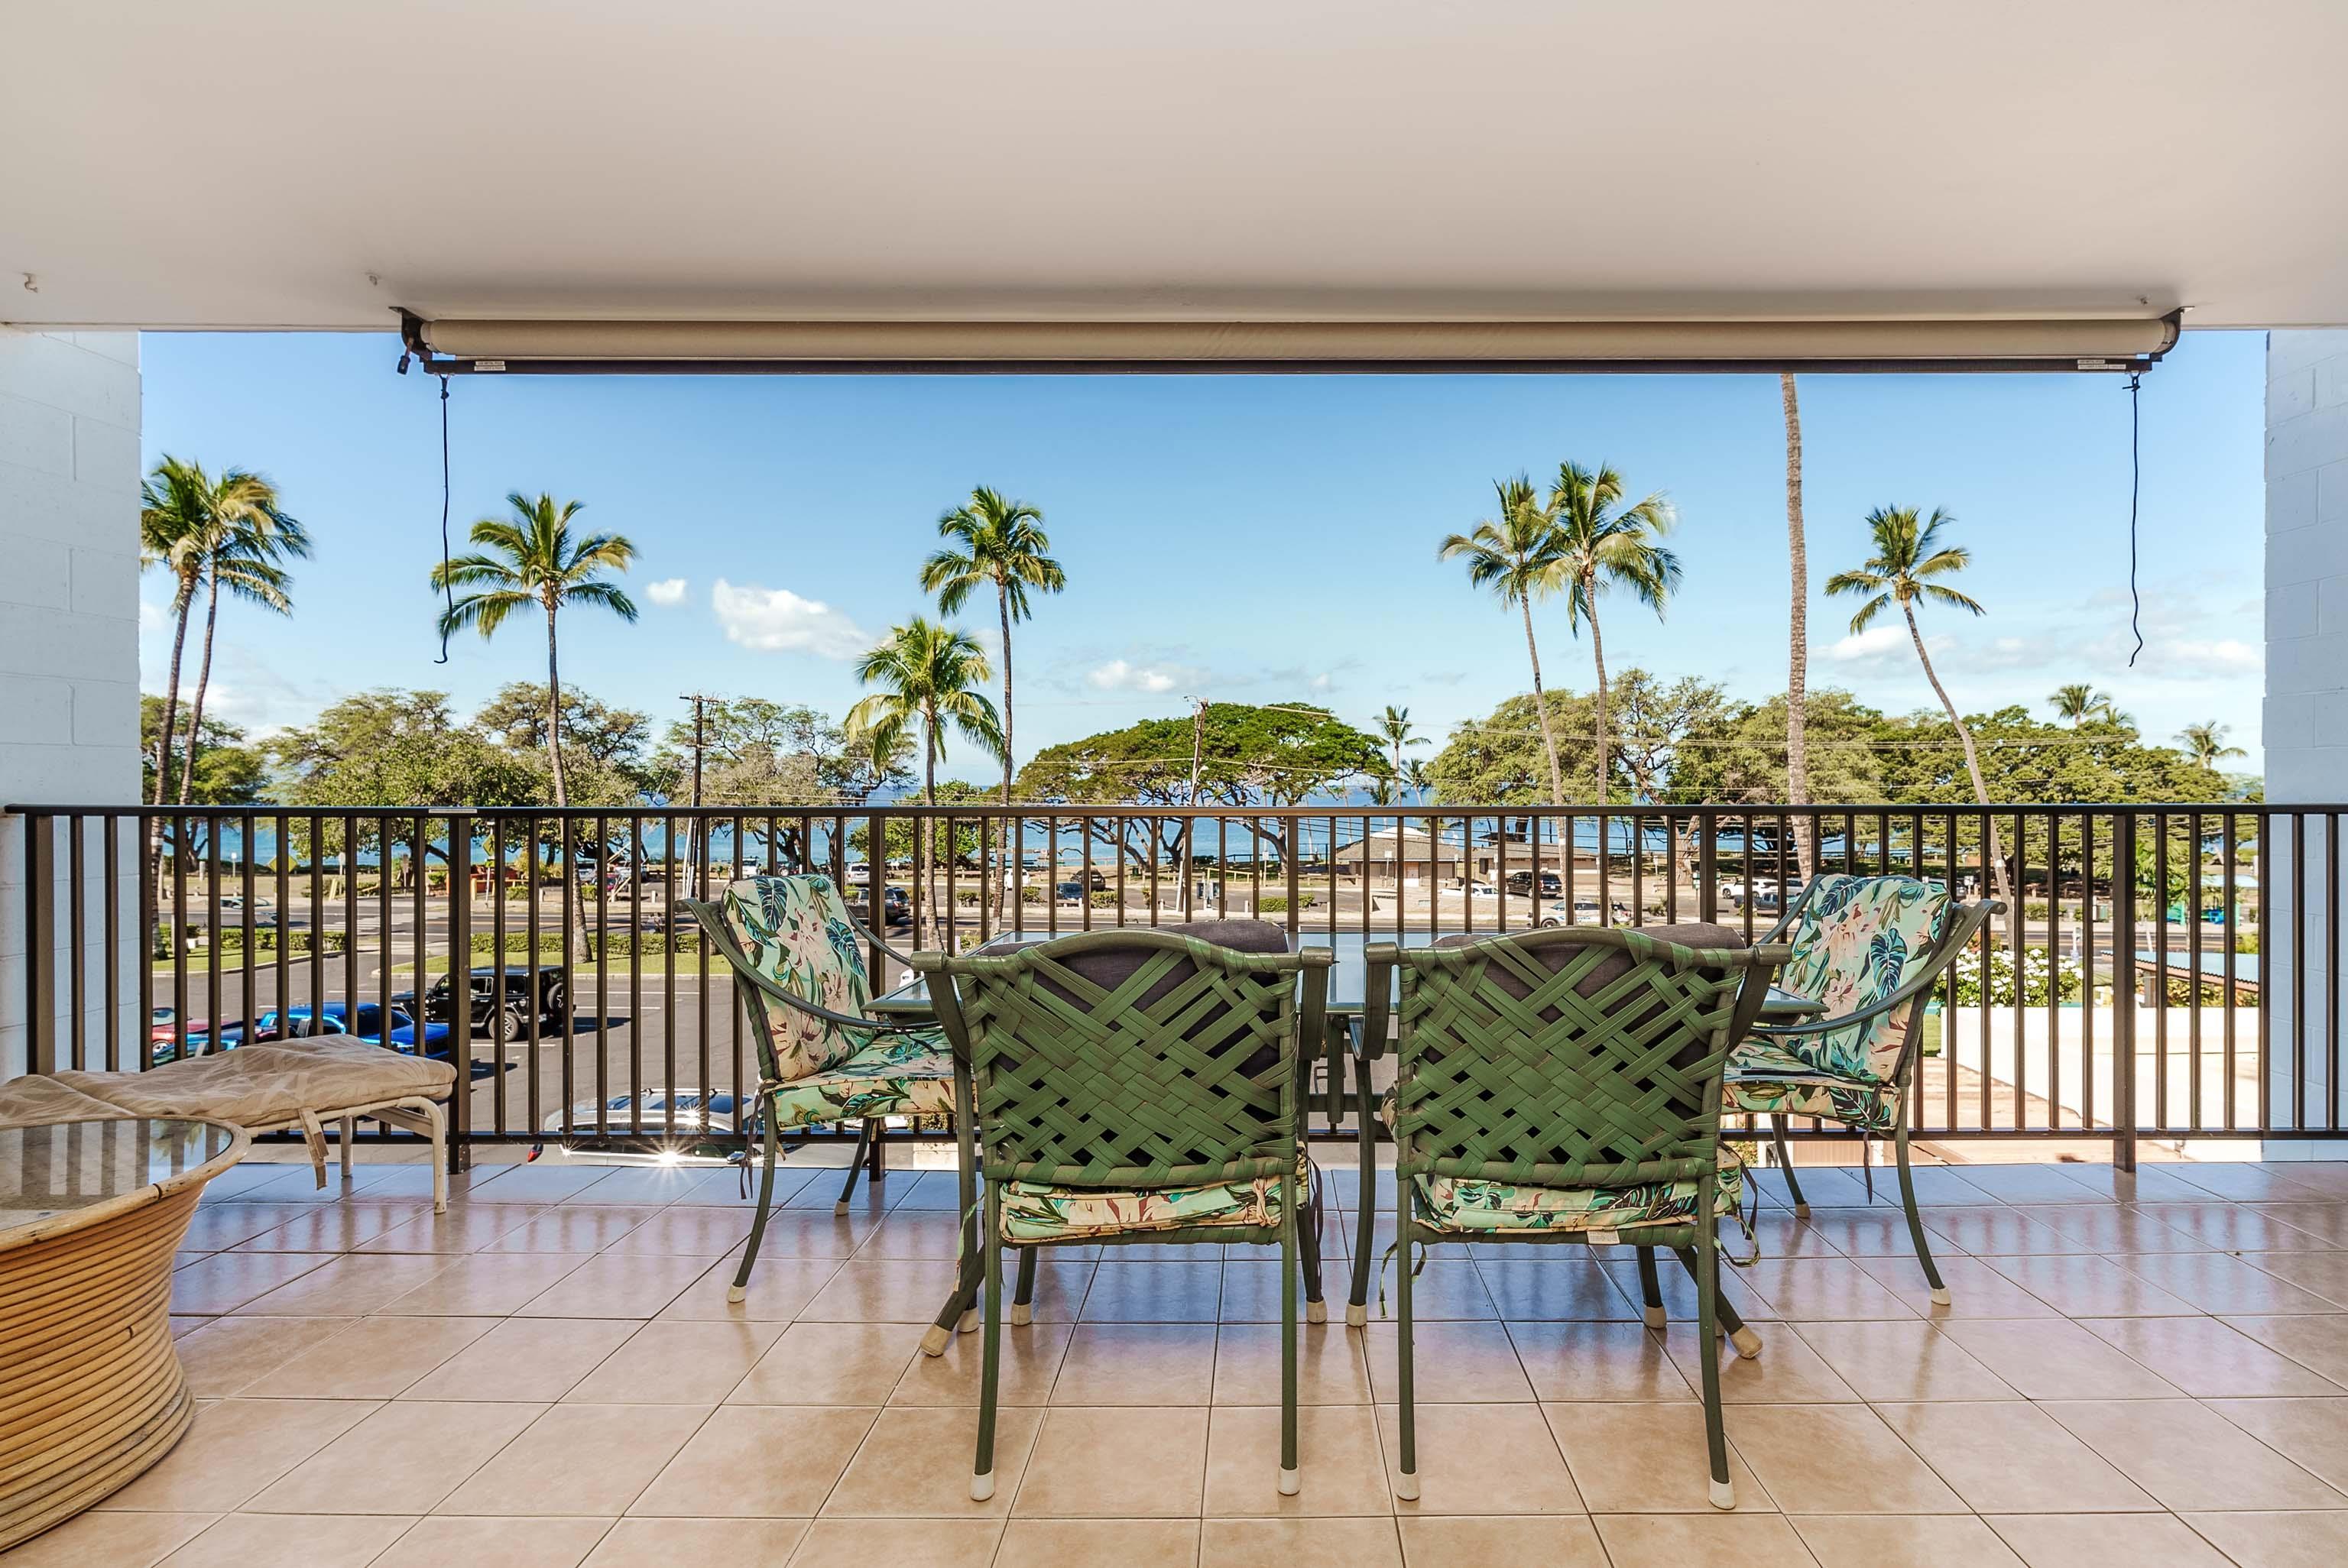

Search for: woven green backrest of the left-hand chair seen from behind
xmin=913 ymin=929 xmax=1327 ymax=1187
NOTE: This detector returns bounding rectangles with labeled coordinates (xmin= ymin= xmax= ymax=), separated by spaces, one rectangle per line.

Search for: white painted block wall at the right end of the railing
xmin=2261 ymin=329 xmax=2348 ymax=1159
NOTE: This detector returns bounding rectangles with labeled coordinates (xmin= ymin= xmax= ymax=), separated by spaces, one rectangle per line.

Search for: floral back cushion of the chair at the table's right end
xmin=1785 ymin=876 xmax=1951 ymax=1082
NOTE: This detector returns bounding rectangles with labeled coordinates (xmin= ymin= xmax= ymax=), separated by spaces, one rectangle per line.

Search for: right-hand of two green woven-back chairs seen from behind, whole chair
xmin=1364 ymin=927 xmax=1787 ymax=1509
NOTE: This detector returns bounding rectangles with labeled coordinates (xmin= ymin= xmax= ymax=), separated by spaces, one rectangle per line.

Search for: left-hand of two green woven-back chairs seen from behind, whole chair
xmin=913 ymin=922 xmax=1334 ymax=1502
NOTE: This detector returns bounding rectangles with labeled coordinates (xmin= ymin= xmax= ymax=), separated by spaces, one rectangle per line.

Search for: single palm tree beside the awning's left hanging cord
xmin=432 ymin=491 xmax=637 ymax=808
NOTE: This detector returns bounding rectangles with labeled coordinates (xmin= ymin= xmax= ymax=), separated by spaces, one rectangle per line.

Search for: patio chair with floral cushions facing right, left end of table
xmin=683 ymin=876 xmax=953 ymax=1301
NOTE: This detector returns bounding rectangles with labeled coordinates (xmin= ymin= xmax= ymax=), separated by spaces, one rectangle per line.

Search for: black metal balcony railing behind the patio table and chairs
xmin=9 ymin=805 xmax=2348 ymax=1157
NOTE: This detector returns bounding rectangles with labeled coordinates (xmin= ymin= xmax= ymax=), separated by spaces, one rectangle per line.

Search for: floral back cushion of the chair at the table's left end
xmin=725 ymin=876 xmax=877 ymax=1084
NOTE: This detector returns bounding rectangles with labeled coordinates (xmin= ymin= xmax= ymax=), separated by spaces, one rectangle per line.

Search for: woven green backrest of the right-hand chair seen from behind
xmin=1395 ymin=929 xmax=1785 ymax=1187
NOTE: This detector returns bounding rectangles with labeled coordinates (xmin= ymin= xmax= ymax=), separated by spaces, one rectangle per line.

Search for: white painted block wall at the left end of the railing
xmin=0 ymin=326 xmax=143 ymax=1077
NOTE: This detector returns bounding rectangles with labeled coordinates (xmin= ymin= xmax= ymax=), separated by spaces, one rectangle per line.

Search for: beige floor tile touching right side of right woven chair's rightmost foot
xmin=1728 ymin=1404 xmax=1965 ymax=1514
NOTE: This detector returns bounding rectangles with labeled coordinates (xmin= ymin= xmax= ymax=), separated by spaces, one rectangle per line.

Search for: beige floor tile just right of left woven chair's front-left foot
xmin=1012 ymin=1406 xmax=1207 ymax=1518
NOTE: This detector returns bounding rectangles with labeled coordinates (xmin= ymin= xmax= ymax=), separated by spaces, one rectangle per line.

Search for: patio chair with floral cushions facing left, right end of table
xmin=1728 ymin=876 xmax=2005 ymax=1305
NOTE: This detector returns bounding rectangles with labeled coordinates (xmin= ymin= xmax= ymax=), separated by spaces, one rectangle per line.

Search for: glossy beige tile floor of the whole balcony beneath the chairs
xmin=5 ymin=1145 xmax=2348 ymax=1568
